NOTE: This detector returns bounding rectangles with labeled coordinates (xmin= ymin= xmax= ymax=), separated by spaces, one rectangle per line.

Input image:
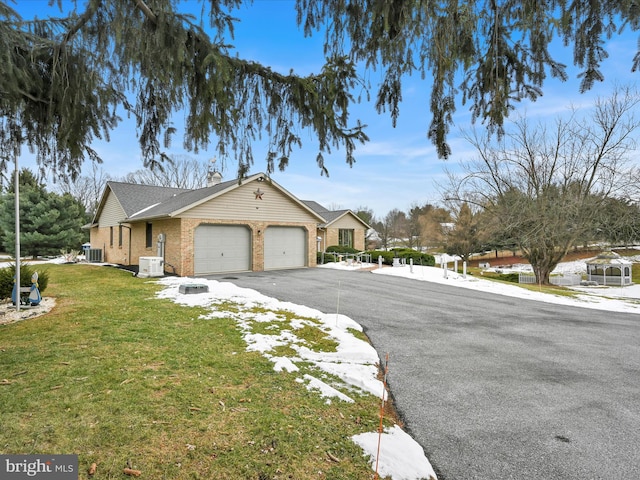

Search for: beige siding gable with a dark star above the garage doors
xmin=180 ymin=182 xmax=319 ymax=223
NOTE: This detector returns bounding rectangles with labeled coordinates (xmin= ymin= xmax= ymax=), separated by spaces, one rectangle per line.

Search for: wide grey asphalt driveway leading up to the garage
xmin=209 ymin=268 xmax=640 ymax=480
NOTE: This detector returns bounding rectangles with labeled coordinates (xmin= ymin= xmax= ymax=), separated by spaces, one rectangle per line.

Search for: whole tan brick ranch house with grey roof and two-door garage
xmin=89 ymin=172 xmax=369 ymax=276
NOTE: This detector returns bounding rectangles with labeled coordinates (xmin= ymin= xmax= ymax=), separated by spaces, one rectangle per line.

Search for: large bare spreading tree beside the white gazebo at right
xmin=448 ymin=87 xmax=640 ymax=284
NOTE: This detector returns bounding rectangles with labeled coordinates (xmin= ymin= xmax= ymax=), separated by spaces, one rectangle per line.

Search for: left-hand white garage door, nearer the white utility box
xmin=193 ymin=225 xmax=251 ymax=275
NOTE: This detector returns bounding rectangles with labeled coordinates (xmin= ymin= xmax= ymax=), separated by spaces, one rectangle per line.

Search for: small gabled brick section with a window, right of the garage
xmin=302 ymin=200 xmax=370 ymax=252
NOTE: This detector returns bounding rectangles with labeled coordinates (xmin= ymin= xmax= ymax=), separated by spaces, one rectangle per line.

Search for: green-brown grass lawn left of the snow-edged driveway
xmin=0 ymin=265 xmax=390 ymax=480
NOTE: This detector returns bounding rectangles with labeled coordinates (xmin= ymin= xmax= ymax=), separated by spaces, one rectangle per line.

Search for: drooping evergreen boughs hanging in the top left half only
xmin=0 ymin=0 xmax=367 ymax=178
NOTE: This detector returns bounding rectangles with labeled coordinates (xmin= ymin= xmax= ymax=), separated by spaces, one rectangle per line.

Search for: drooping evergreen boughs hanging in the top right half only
xmin=296 ymin=0 xmax=640 ymax=158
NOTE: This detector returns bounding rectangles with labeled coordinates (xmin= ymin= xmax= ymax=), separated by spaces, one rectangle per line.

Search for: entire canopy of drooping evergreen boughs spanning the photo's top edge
xmin=0 ymin=0 xmax=640 ymax=178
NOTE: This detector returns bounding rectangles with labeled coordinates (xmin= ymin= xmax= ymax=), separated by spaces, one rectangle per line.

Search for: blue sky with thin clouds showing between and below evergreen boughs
xmin=15 ymin=0 xmax=638 ymax=219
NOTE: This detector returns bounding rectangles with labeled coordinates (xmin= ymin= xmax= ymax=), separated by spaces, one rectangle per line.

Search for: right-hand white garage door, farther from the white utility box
xmin=264 ymin=227 xmax=307 ymax=270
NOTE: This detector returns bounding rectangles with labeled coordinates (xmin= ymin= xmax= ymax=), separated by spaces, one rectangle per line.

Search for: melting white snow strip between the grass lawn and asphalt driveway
xmin=156 ymin=277 xmax=436 ymax=480
